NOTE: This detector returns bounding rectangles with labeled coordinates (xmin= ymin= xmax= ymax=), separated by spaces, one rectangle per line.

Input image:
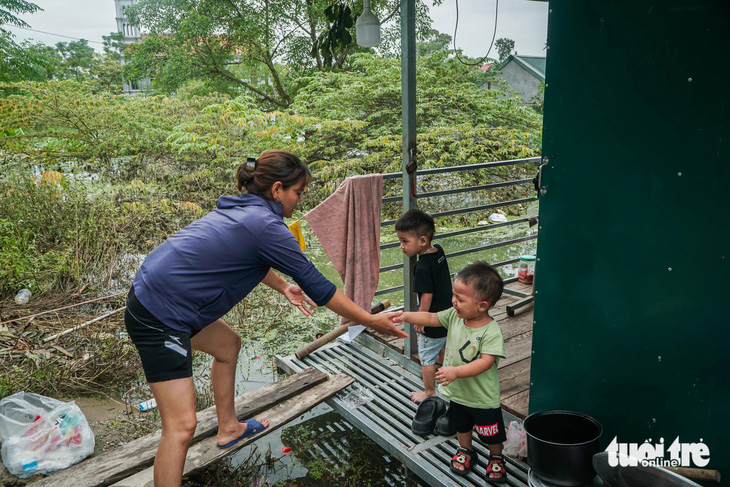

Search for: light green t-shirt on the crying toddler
xmin=438 ymin=308 xmax=505 ymax=409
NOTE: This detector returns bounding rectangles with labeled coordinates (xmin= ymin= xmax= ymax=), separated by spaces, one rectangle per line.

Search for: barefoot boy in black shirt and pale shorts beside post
xmin=395 ymin=210 xmax=451 ymax=403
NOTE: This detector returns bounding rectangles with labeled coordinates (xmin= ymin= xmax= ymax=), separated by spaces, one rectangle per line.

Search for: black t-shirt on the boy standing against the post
xmin=413 ymin=245 xmax=451 ymax=338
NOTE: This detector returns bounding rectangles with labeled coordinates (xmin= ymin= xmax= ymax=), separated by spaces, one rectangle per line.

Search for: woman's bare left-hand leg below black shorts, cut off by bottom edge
xmin=150 ymin=377 xmax=197 ymax=487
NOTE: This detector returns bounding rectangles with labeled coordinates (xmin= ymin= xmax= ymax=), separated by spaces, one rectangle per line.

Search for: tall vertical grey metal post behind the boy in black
xmin=400 ymin=0 xmax=418 ymax=359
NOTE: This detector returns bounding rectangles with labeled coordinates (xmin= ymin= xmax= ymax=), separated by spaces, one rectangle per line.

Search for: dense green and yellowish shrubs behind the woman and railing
xmin=0 ymin=46 xmax=541 ymax=392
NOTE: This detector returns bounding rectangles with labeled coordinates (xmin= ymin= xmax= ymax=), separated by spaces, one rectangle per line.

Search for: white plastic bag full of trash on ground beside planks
xmin=0 ymin=392 xmax=94 ymax=478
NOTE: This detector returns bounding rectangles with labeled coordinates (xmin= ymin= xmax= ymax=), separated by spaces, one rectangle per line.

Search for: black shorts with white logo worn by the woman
xmin=124 ymin=287 xmax=193 ymax=382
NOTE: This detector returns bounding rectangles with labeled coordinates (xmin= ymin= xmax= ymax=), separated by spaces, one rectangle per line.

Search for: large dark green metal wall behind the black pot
xmin=530 ymin=0 xmax=730 ymax=476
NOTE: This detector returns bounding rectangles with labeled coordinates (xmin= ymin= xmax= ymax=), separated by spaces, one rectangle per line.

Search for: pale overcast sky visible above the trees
xmin=3 ymin=0 xmax=548 ymax=58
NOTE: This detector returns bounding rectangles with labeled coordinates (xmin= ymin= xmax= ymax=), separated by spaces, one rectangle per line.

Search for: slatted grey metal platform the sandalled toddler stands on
xmin=276 ymin=343 xmax=528 ymax=487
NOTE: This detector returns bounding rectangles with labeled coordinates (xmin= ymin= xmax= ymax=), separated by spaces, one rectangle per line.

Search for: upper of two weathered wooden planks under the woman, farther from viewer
xmin=33 ymin=369 xmax=327 ymax=487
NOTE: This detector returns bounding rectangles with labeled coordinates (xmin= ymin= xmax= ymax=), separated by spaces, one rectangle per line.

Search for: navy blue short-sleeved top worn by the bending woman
xmin=133 ymin=194 xmax=337 ymax=333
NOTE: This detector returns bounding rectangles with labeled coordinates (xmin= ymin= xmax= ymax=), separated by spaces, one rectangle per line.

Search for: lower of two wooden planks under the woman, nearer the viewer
xmin=114 ymin=374 xmax=355 ymax=487
